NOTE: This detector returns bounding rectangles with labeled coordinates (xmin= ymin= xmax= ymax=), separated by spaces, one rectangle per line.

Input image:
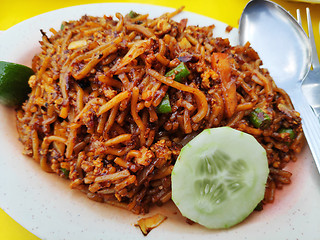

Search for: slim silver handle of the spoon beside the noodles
xmin=290 ymin=86 xmax=320 ymax=172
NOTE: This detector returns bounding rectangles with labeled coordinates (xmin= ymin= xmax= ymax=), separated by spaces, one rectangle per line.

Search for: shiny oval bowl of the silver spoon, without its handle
xmin=239 ymin=0 xmax=311 ymax=88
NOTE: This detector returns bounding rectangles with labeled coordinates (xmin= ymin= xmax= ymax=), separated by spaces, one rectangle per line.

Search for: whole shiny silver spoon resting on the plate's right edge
xmin=239 ymin=0 xmax=320 ymax=172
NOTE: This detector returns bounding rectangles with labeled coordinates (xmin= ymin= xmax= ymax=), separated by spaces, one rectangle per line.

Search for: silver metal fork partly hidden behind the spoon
xmin=297 ymin=8 xmax=320 ymax=119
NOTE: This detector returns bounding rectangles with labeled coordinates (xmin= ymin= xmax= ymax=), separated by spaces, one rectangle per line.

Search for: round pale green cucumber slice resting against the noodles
xmin=171 ymin=127 xmax=269 ymax=229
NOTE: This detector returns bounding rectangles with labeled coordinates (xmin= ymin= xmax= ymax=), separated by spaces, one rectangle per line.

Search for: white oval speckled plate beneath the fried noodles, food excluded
xmin=0 ymin=3 xmax=320 ymax=240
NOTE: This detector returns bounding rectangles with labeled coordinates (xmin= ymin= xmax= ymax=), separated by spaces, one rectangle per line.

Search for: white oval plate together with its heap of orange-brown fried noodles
xmin=0 ymin=3 xmax=320 ymax=239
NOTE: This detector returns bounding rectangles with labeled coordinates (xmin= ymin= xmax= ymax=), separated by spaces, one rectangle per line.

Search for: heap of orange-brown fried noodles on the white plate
xmin=17 ymin=9 xmax=303 ymax=214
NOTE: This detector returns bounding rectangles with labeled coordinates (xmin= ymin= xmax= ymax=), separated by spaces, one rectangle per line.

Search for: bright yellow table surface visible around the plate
xmin=0 ymin=0 xmax=320 ymax=240
